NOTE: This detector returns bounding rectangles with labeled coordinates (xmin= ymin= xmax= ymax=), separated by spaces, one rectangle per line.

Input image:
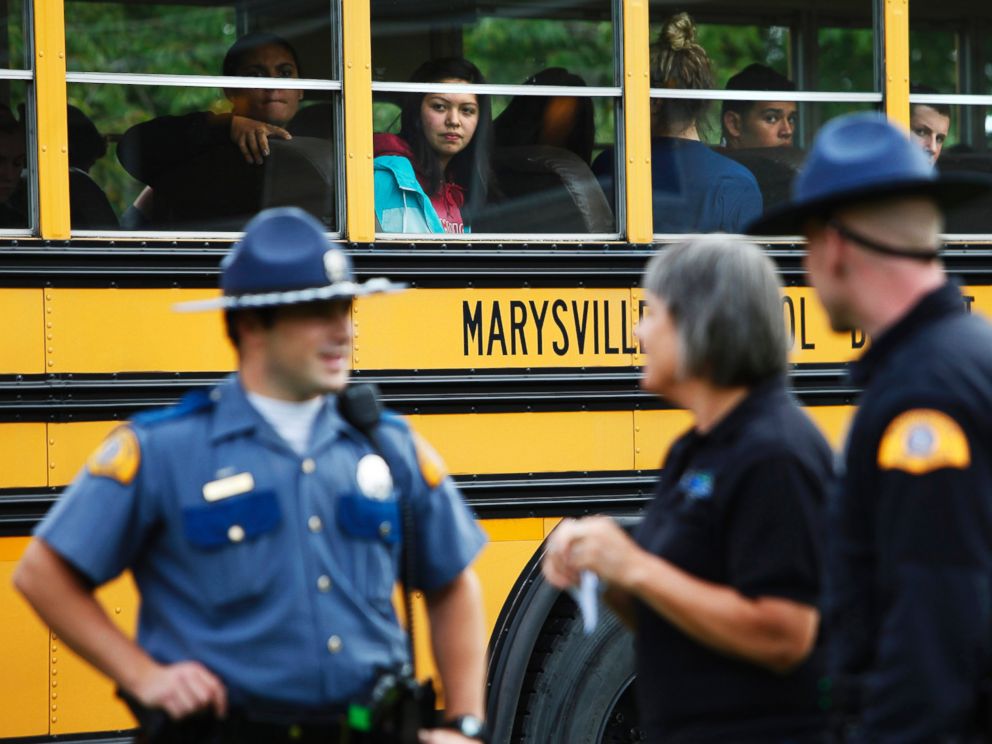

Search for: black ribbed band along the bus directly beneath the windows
xmin=0 ymin=244 xmax=992 ymax=289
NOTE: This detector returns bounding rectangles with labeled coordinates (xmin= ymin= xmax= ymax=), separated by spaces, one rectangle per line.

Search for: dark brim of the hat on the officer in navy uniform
xmin=745 ymin=173 xmax=992 ymax=235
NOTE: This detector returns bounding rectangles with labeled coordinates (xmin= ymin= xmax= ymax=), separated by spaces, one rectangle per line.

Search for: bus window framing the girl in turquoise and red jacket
xmin=372 ymin=0 xmax=620 ymax=237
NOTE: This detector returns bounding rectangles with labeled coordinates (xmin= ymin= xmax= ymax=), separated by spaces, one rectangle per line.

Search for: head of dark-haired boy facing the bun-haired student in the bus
xmin=720 ymin=62 xmax=798 ymax=150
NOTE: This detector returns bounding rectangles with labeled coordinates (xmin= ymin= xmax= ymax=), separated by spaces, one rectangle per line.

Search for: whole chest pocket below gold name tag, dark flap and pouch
xmin=182 ymin=491 xmax=282 ymax=605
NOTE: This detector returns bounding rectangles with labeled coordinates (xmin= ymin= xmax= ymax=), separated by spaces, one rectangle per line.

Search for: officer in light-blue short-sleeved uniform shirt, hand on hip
xmin=15 ymin=209 xmax=494 ymax=744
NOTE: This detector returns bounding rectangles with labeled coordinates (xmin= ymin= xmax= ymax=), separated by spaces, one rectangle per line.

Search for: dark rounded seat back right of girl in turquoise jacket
xmin=472 ymin=145 xmax=616 ymax=233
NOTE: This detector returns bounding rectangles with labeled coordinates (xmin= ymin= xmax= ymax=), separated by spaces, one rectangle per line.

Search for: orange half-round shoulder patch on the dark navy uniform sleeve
xmin=878 ymin=408 xmax=971 ymax=475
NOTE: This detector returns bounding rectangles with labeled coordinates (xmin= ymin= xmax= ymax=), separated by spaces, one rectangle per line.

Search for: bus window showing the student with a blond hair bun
xmin=644 ymin=2 xmax=882 ymax=236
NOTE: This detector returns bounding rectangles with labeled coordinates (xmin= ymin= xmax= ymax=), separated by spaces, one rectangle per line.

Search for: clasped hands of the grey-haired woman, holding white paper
xmin=541 ymin=517 xmax=643 ymax=589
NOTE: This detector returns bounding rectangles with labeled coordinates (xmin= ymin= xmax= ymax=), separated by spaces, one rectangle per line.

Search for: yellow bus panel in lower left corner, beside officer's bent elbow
xmin=0 ymin=537 xmax=50 ymax=738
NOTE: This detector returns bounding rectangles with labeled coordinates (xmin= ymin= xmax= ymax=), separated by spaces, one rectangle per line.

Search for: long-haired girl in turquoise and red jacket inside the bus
xmin=373 ymin=57 xmax=493 ymax=233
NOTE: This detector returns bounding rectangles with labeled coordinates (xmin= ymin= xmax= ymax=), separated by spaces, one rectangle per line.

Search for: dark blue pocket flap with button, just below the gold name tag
xmin=183 ymin=491 xmax=282 ymax=549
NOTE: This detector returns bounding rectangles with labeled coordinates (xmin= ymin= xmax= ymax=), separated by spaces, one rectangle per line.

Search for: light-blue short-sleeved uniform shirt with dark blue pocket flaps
xmin=37 ymin=378 xmax=485 ymax=711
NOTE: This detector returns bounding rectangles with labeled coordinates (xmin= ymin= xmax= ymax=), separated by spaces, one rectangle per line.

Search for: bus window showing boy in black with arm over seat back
xmin=66 ymin=0 xmax=341 ymax=232
